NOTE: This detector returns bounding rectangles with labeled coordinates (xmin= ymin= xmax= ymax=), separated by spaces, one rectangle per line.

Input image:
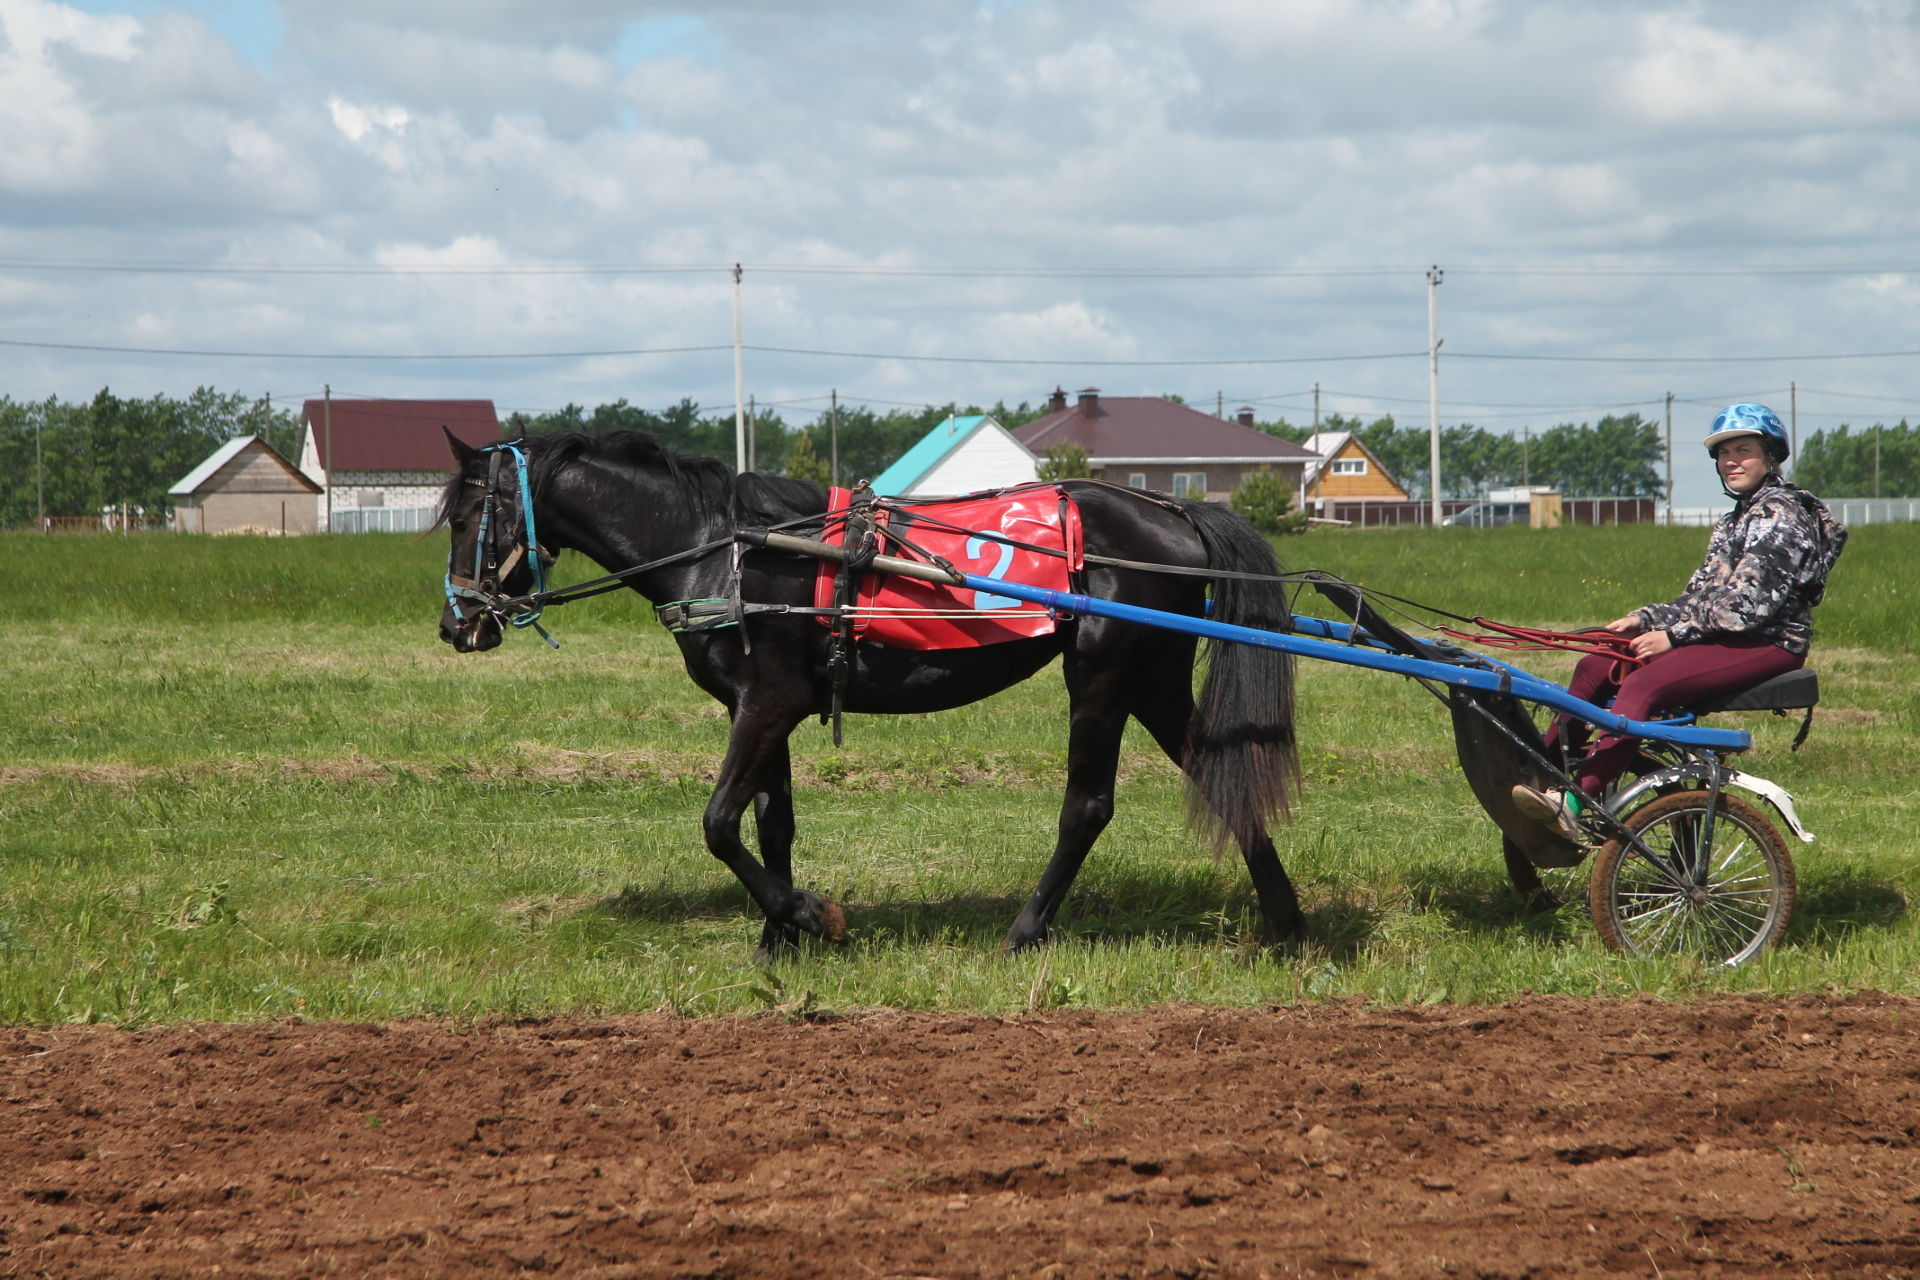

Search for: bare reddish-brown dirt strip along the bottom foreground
xmin=0 ymin=994 xmax=1920 ymax=1280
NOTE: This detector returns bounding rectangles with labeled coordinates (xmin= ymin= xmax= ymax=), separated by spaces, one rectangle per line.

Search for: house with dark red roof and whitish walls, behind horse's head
xmin=300 ymin=399 xmax=499 ymax=533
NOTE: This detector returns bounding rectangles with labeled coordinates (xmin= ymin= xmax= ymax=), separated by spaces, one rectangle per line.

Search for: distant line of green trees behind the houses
xmin=0 ymin=388 xmax=1920 ymax=528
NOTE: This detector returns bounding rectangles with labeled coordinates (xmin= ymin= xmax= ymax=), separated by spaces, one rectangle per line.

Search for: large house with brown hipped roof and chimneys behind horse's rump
xmin=1014 ymin=388 xmax=1313 ymax=501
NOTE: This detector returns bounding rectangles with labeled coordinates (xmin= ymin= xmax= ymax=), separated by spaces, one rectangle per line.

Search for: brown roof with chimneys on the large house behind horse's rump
xmin=1014 ymin=391 xmax=1315 ymax=466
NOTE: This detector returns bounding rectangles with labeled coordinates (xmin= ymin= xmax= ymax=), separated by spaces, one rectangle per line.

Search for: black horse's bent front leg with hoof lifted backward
xmin=701 ymin=712 xmax=847 ymax=942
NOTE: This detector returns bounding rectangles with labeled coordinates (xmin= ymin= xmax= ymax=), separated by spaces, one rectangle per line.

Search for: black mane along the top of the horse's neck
xmin=442 ymin=430 xmax=828 ymax=526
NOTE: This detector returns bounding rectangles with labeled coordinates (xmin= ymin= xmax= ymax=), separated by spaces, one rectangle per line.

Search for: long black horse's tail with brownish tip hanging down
xmin=1183 ymin=503 xmax=1300 ymax=848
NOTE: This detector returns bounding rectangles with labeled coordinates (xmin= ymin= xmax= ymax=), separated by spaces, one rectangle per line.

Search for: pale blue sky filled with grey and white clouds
xmin=0 ymin=0 xmax=1920 ymax=507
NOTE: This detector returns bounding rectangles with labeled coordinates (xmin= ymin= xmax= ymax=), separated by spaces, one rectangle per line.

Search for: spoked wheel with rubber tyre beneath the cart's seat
xmin=1586 ymin=791 xmax=1793 ymax=965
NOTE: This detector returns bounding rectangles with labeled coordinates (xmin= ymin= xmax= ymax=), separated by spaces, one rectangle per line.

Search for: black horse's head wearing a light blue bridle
xmin=440 ymin=432 xmax=549 ymax=652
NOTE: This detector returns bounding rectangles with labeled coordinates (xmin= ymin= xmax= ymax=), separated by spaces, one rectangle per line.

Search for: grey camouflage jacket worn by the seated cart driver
xmin=1634 ymin=476 xmax=1847 ymax=652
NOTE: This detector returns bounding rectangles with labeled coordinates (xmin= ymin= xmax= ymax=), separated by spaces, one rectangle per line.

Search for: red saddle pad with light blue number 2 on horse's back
xmin=814 ymin=484 xmax=1085 ymax=649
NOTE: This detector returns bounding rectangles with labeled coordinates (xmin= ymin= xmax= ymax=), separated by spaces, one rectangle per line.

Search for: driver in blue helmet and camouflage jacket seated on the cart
xmin=1513 ymin=403 xmax=1847 ymax=841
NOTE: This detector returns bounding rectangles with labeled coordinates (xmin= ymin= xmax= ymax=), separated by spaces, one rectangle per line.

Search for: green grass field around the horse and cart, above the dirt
xmin=0 ymin=526 xmax=1920 ymax=1023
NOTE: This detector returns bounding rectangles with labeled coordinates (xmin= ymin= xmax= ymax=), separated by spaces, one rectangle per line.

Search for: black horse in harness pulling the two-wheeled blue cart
xmin=440 ymin=432 xmax=1304 ymax=950
